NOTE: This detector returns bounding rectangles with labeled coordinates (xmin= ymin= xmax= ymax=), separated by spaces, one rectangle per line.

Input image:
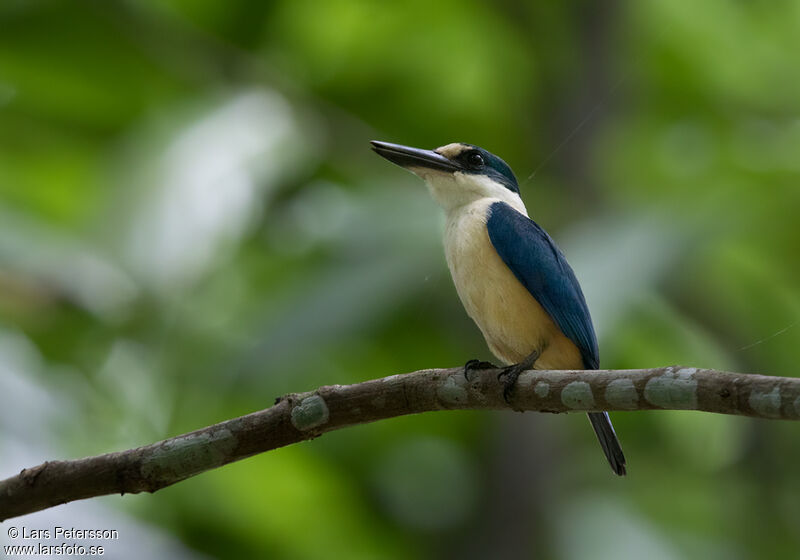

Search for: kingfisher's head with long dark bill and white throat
xmin=372 ymin=140 xmax=526 ymax=213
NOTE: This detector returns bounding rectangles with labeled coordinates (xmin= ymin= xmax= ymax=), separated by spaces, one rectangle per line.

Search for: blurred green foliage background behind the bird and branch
xmin=0 ymin=0 xmax=800 ymax=560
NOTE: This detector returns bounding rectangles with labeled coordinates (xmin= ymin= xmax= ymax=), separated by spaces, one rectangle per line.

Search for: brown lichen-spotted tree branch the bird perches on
xmin=0 ymin=366 xmax=800 ymax=521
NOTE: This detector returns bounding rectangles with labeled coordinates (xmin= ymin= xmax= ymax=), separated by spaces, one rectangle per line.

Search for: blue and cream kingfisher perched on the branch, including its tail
xmin=371 ymin=141 xmax=625 ymax=476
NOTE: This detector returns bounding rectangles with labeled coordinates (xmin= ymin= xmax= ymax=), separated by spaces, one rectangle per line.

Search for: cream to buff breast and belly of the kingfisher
xmin=444 ymin=199 xmax=582 ymax=369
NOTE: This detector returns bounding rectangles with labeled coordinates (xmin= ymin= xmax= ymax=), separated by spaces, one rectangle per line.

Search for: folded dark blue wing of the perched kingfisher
xmin=486 ymin=202 xmax=600 ymax=369
